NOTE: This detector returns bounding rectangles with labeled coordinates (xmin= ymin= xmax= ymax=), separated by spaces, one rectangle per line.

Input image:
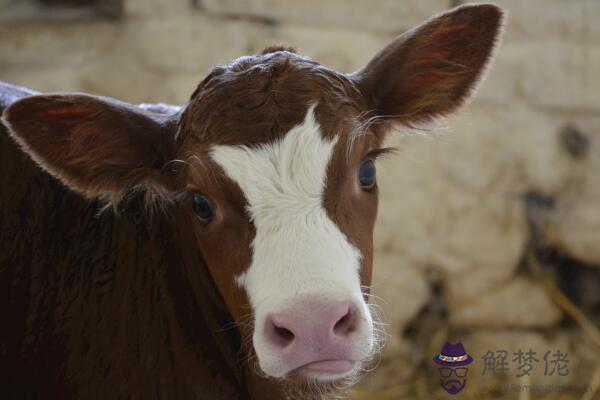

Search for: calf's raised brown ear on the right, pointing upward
xmin=350 ymin=4 xmax=504 ymax=125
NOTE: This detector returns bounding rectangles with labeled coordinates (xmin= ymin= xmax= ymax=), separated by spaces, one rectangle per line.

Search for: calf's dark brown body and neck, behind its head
xmin=0 ymin=84 xmax=254 ymax=400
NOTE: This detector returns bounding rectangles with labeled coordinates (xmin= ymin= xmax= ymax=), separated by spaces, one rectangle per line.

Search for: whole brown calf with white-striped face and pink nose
xmin=0 ymin=5 xmax=503 ymax=400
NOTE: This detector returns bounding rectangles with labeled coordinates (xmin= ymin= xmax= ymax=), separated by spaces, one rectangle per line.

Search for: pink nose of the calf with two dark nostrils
xmin=265 ymin=301 xmax=359 ymax=373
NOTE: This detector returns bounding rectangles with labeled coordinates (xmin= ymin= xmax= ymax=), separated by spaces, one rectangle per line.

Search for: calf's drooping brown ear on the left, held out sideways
xmin=3 ymin=94 xmax=174 ymax=204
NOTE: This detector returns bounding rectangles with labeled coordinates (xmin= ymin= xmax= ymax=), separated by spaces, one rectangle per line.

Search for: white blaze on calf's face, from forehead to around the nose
xmin=212 ymin=106 xmax=372 ymax=376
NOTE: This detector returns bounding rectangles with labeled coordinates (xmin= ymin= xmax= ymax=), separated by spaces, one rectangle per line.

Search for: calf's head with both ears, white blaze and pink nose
xmin=4 ymin=5 xmax=502 ymax=396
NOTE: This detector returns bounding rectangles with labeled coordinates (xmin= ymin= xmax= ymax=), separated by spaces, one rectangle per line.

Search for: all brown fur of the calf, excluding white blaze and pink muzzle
xmin=0 ymin=5 xmax=502 ymax=400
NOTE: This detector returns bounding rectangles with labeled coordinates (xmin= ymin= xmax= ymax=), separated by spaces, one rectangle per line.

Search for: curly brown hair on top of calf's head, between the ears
xmin=182 ymin=51 xmax=364 ymax=145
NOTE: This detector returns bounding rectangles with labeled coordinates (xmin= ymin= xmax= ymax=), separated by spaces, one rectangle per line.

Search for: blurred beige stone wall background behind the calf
xmin=0 ymin=0 xmax=600 ymax=400
